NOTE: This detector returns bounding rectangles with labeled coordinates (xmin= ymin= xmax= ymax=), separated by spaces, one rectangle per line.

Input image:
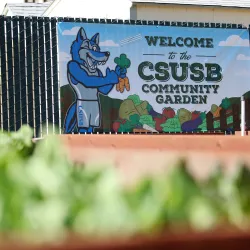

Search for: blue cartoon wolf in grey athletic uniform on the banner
xmin=64 ymin=28 xmax=126 ymax=134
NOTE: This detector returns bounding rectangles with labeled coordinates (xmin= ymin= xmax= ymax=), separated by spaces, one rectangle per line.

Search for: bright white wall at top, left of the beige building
xmin=43 ymin=0 xmax=131 ymax=19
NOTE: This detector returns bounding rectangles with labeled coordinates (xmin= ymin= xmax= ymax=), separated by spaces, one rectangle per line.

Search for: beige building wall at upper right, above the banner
xmin=134 ymin=5 xmax=250 ymax=25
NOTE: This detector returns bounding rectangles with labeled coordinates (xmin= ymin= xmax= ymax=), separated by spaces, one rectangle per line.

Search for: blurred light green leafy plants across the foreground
xmin=0 ymin=126 xmax=250 ymax=244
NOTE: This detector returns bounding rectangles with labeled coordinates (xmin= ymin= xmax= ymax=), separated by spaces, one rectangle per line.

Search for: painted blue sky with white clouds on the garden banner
xmin=58 ymin=23 xmax=250 ymax=111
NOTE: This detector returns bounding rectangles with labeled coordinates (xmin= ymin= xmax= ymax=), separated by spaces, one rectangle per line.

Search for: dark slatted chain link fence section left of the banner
xmin=0 ymin=16 xmax=60 ymax=137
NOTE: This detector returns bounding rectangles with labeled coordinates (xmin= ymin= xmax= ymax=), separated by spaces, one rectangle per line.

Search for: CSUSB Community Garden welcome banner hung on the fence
xmin=58 ymin=22 xmax=250 ymax=133
